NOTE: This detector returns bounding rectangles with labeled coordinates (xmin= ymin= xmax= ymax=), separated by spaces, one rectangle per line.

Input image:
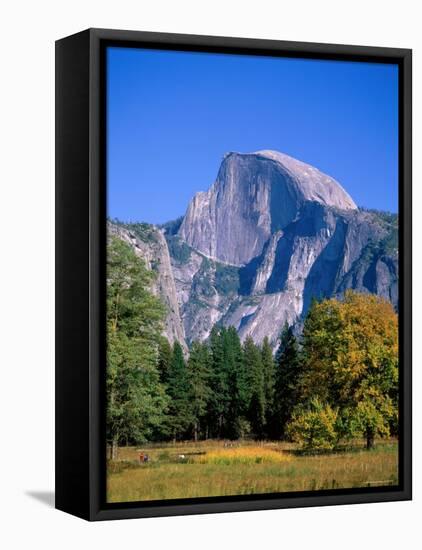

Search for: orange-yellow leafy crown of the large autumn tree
xmin=303 ymin=291 xmax=398 ymax=403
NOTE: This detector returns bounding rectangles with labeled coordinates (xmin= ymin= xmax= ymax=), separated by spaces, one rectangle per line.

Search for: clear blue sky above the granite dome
xmin=107 ymin=47 xmax=398 ymax=223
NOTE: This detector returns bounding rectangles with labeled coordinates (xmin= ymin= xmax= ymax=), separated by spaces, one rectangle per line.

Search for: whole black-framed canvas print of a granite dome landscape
xmin=56 ymin=29 xmax=411 ymax=520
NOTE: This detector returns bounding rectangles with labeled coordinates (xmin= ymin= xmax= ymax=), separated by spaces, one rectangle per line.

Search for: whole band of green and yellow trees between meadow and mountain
xmin=107 ymin=237 xmax=398 ymax=457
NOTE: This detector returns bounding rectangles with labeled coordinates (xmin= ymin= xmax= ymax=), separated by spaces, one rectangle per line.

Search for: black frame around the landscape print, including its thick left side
xmin=56 ymin=29 xmax=412 ymax=520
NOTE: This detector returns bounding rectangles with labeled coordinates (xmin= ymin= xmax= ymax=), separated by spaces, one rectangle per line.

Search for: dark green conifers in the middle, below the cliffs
xmin=158 ymin=326 xmax=299 ymax=441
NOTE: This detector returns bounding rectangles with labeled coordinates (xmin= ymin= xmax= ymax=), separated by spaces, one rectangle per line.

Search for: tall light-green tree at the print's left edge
xmin=106 ymin=237 xmax=167 ymax=448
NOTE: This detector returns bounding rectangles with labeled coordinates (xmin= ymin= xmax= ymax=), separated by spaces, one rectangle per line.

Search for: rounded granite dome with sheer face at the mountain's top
xmin=178 ymin=151 xmax=356 ymax=266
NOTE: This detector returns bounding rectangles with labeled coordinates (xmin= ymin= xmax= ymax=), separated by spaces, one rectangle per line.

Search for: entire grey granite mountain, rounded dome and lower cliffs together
xmin=110 ymin=151 xmax=398 ymax=346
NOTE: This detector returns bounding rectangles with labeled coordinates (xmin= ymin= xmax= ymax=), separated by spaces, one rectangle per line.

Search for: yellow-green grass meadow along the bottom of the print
xmin=107 ymin=439 xmax=398 ymax=502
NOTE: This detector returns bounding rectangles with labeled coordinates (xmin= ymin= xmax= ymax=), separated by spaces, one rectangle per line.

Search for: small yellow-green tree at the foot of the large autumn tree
xmin=287 ymin=398 xmax=338 ymax=451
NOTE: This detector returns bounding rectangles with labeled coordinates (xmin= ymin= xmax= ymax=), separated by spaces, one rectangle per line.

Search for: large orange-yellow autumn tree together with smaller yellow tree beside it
xmin=289 ymin=291 xmax=398 ymax=449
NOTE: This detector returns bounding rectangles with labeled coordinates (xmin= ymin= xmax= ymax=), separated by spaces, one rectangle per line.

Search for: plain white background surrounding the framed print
xmin=0 ymin=0 xmax=422 ymax=550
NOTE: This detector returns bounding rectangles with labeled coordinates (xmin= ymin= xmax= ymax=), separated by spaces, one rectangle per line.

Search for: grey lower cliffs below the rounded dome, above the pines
xmin=172 ymin=203 xmax=398 ymax=345
